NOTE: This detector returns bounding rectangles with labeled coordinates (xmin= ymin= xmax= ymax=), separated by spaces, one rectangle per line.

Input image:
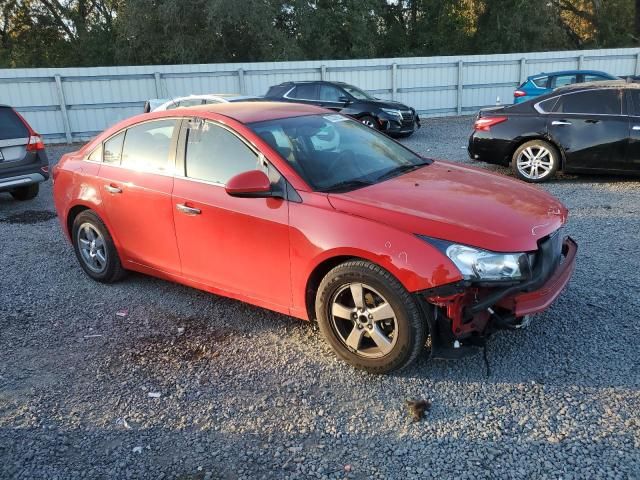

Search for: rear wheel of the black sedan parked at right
xmin=511 ymin=139 xmax=560 ymax=183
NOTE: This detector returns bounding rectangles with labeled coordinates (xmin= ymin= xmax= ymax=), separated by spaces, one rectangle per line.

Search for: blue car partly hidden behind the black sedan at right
xmin=513 ymin=70 xmax=620 ymax=103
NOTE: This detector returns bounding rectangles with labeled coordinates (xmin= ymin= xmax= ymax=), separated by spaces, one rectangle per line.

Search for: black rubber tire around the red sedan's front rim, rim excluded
xmin=315 ymin=260 xmax=428 ymax=374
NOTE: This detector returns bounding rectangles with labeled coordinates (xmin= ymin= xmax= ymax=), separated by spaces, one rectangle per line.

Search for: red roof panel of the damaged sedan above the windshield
xmin=180 ymin=102 xmax=331 ymax=123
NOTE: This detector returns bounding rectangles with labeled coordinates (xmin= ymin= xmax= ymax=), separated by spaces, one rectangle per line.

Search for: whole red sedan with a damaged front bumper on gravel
xmin=54 ymin=102 xmax=577 ymax=373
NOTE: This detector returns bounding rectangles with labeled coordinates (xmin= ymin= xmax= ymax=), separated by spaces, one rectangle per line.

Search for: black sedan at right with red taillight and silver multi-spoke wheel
xmin=468 ymin=81 xmax=640 ymax=182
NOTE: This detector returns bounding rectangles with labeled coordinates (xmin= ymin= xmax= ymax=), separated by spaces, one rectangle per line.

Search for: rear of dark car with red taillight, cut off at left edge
xmin=0 ymin=105 xmax=49 ymax=200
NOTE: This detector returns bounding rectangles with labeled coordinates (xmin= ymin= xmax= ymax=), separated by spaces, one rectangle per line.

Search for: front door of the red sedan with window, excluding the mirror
xmin=173 ymin=121 xmax=291 ymax=311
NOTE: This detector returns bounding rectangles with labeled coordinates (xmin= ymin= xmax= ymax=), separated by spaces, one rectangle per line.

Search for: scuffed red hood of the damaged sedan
xmin=329 ymin=161 xmax=568 ymax=252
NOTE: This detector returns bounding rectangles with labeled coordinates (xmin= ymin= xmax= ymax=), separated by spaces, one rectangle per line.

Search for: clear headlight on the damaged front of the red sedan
xmin=420 ymin=236 xmax=529 ymax=281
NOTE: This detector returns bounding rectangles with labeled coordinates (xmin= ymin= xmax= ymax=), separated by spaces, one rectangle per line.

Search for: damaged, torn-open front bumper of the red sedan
xmin=417 ymin=237 xmax=578 ymax=358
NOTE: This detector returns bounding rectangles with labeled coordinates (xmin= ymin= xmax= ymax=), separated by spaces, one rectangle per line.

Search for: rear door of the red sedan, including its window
xmin=99 ymin=119 xmax=180 ymax=275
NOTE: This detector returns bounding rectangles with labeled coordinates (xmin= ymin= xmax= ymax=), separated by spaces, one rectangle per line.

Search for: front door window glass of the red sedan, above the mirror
xmin=185 ymin=122 xmax=260 ymax=185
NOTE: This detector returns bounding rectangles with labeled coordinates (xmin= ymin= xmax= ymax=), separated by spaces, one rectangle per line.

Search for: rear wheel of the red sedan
xmin=71 ymin=210 xmax=126 ymax=283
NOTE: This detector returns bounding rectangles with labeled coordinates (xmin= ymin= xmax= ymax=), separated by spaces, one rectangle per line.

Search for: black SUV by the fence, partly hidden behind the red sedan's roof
xmin=265 ymin=81 xmax=420 ymax=137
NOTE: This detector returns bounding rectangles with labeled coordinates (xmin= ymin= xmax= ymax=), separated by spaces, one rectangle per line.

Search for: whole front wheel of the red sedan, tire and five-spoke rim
xmin=316 ymin=260 xmax=427 ymax=374
